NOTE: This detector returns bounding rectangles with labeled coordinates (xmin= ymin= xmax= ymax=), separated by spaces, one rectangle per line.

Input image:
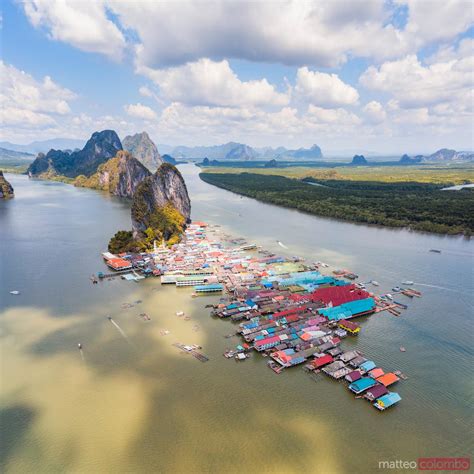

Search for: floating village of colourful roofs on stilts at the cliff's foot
xmin=97 ymin=222 xmax=421 ymax=411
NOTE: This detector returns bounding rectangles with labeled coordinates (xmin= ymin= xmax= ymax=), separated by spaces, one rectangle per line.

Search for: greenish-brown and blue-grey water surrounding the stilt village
xmin=0 ymin=165 xmax=474 ymax=473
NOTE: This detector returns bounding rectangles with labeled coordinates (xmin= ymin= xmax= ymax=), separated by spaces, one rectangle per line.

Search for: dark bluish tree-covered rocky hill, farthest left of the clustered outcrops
xmin=28 ymin=130 xmax=122 ymax=178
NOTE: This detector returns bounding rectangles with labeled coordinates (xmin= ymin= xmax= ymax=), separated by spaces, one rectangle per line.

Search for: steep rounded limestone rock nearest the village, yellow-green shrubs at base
xmin=132 ymin=163 xmax=191 ymax=239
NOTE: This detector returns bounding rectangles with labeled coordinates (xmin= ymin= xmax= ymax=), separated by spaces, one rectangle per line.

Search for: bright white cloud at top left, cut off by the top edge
xmin=23 ymin=0 xmax=125 ymax=60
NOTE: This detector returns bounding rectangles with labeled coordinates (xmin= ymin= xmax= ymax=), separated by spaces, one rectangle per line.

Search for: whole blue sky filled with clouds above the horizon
xmin=0 ymin=0 xmax=474 ymax=155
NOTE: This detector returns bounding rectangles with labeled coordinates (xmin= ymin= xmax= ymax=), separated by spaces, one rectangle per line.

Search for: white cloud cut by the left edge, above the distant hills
xmin=0 ymin=61 xmax=76 ymax=127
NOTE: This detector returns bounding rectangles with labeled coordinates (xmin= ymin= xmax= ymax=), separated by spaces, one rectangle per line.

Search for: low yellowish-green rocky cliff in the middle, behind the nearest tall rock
xmin=74 ymin=150 xmax=151 ymax=198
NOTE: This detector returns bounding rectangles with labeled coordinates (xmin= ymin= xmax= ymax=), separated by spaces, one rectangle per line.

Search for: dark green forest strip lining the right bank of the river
xmin=199 ymin=173 xmax=474 ymax=235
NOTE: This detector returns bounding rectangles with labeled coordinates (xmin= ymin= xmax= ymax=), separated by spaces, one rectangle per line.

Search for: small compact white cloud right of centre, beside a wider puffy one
xmin=295 ymin=67 xmax=359 ymax=107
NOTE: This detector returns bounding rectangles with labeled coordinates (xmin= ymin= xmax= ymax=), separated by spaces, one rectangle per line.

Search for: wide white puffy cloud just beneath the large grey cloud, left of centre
xmin=138 ymin=59 xmax=289 ymax=107
